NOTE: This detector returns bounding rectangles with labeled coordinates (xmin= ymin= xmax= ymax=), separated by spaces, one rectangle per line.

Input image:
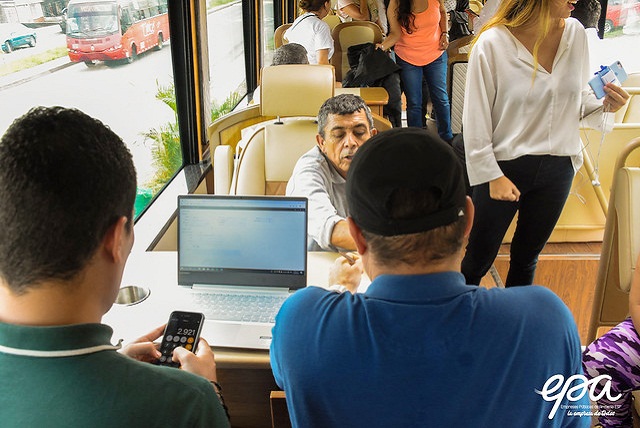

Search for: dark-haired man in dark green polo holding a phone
xmin=0 ymin=107 xmax=229 ymax=428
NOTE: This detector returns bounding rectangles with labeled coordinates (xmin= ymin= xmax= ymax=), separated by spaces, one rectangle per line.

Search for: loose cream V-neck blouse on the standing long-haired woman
xmin=462 ymin=18 xmax=607 ymax=185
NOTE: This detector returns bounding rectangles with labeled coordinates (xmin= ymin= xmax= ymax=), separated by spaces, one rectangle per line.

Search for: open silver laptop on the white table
xmin=178 ymin=195 xmax=307 ymax=349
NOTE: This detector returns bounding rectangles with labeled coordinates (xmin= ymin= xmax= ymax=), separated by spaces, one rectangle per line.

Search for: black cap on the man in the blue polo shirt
xmin=347 ymin=128 xmax=466 ymax=236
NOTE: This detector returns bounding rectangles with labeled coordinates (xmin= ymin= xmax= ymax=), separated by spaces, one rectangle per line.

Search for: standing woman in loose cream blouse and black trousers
xmin=462 ymin=0 xmax=629 ymax=286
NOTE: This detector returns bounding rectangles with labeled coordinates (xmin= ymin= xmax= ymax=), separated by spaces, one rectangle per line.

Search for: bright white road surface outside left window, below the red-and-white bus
xmin=0 ymin=40 xmax=174 ymax=184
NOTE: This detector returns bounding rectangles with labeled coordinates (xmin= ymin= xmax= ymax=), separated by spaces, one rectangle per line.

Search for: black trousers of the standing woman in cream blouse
xmin=462 ymin=155 xmax=574 ymax=287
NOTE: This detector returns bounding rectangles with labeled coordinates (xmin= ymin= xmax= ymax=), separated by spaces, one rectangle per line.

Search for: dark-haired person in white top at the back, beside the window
xmin=283 ymin=0 xmax=334 ymax=64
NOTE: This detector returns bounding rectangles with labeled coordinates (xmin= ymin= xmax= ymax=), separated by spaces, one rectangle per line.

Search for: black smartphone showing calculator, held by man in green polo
xmin=157 ymin=311 xmax=204 ymax=367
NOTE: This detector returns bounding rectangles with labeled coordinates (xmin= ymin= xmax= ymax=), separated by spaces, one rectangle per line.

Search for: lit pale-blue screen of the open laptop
xmin=178 ymin=195 xmax=307 ymax=289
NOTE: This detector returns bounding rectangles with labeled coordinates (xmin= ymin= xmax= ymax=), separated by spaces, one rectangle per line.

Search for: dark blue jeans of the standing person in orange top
xmin=396 ymin=51 xmax=453 ymax=142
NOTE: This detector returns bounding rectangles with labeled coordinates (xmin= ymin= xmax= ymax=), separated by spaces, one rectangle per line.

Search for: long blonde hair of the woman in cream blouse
xmin=472 ymin=0 xmax=551 ymax=79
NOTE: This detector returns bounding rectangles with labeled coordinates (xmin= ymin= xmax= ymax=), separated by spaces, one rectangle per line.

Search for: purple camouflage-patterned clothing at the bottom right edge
xmin=582 ymin=318 xmax=640 ymax=428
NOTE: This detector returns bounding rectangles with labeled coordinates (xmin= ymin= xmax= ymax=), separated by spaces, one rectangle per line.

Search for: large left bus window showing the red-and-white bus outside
xmin=0 ymin=0 xmax=182 ymax=214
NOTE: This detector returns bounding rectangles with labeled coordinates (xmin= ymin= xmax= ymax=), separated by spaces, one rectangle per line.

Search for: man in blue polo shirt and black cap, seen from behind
xmin=271 ymin=128 xmax=590 ymax=428
